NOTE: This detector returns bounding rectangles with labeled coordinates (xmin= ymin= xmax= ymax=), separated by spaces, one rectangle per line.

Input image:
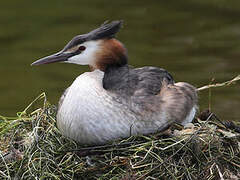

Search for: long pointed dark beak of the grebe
xmin=31 ymin=52 xmax=71 ymax=66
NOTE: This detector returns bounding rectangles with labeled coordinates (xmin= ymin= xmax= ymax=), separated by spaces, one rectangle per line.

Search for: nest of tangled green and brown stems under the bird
xmin=0 ymin=94 xmax=240 ymax=180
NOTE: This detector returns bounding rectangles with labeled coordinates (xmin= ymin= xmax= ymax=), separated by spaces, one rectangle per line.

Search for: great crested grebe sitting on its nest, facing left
xmin=32 ymin=21 xmax=197 ymax=145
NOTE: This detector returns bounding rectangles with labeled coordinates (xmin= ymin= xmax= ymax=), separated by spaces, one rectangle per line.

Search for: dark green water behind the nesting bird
xmin=0 ymin=0 xmax=240 ymax=120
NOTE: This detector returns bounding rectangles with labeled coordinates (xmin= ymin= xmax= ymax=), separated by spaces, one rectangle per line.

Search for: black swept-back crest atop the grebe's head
xmin=63 ymin=21 xmax=122 ymax=51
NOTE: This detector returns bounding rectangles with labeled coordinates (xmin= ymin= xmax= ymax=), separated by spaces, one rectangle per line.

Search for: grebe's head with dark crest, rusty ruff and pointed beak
xmin=31 ymin=21 xmax=127 ymax=71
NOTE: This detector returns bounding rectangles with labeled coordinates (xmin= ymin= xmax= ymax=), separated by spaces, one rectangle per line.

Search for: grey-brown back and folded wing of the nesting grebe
xmin=103 ymin=66 xmax=197 ymax=123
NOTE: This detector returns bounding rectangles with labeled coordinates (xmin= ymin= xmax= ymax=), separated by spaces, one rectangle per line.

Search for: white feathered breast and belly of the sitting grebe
xmin=57 ymin=70 xmax=175 ymax=144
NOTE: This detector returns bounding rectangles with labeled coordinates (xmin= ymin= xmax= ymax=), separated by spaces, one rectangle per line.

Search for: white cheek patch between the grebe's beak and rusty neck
xmin=67 ymin=41 xmax=100 ymax=65
